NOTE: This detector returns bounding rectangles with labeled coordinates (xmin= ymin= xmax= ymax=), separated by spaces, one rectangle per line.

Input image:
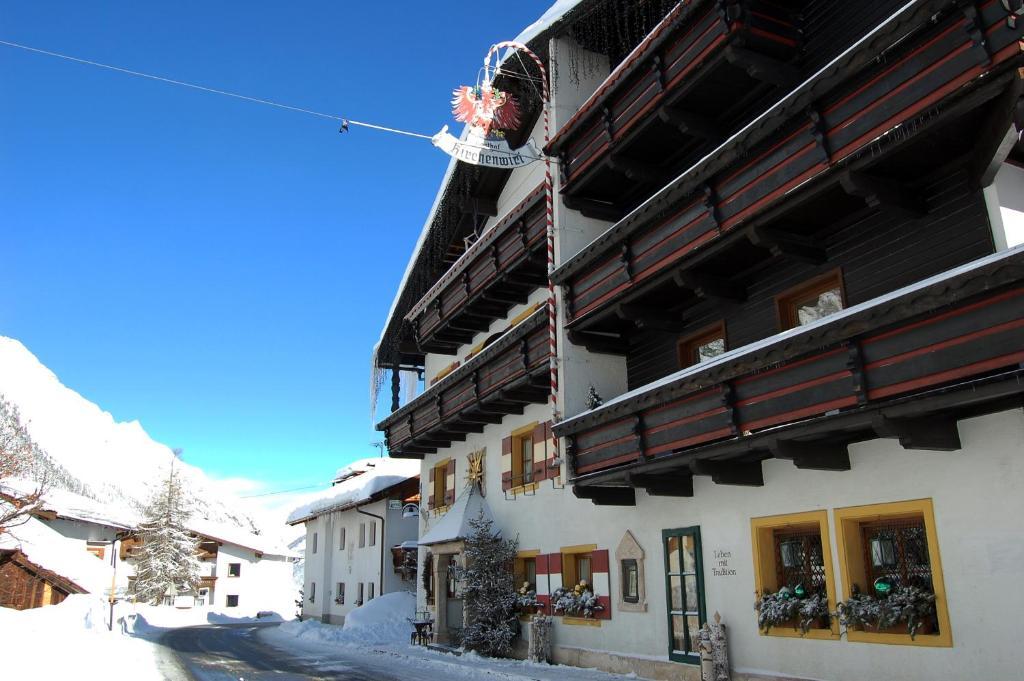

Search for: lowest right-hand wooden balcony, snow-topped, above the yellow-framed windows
xmin=554 ymin=247 xmax=1024 ymax=503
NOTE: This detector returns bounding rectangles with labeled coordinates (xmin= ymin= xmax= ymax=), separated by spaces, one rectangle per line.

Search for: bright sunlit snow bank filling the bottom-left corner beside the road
xmin=0 ymin=594 xmax=166 ymax=681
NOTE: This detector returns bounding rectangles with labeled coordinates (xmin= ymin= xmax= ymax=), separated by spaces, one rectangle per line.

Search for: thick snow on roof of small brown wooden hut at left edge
xmin=0 ymin=518 xmax=113 ymax=594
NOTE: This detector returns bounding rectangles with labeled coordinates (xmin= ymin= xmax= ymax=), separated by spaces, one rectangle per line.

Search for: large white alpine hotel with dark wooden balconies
xmin=375 ymin=0 xmax=1024 ymax=680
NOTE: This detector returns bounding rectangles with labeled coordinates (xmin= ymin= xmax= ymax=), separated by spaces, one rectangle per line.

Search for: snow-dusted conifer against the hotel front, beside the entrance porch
xmin=458 ymin=512 xmax=518 ymax=656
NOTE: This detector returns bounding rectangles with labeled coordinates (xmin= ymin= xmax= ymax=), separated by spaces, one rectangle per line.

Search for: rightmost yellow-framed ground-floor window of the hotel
xmin=834 ymin=499 xmax=953 ymax=647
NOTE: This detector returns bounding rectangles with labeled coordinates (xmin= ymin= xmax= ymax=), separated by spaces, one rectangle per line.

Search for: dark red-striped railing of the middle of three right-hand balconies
xmin=554 ymin=0 xmax=1024 ymax=328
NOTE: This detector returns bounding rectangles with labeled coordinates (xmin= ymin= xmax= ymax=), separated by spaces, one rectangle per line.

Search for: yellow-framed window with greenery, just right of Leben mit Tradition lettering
xmin=751 ymin=511 xmax=839 ymax=639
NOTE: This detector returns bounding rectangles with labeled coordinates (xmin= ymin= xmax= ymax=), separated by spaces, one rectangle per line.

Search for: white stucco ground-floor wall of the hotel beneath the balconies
xmin=419 ymin=406 xmax=1024 ymax=681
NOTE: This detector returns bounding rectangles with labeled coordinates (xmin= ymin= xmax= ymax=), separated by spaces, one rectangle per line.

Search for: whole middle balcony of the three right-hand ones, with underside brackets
xmin=554 ymin=0 xmax=1024 ymax=329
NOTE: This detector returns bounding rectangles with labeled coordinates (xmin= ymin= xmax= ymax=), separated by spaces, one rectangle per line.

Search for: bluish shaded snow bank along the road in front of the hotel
xmin=259 ymin=593 xmax=637 ymax=681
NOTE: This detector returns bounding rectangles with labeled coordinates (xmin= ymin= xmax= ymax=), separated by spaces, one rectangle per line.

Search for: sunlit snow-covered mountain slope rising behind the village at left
xmin=0 ymin=336 xmax=259 ymax=531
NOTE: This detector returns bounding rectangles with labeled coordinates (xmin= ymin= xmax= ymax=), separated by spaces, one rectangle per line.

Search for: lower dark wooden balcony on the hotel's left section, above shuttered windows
xmin=377 ymin=308 xmax=550 ymax=459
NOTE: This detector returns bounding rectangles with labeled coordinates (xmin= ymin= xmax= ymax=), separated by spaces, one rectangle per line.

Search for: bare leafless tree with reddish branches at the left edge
xmin=0 ymin=393 xmax=49 ymax=531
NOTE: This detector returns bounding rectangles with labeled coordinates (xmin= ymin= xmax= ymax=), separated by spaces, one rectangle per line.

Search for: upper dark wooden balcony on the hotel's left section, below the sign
xmin=406 ymin=185 xmax=548 ymax=354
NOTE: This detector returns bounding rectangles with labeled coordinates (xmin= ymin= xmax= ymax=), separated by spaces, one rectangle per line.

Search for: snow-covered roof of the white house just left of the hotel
xmin=287 ymin=459 xmax=420 ymax=524
